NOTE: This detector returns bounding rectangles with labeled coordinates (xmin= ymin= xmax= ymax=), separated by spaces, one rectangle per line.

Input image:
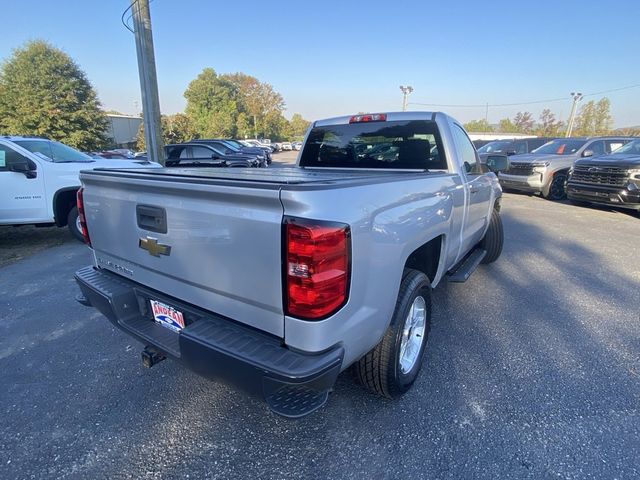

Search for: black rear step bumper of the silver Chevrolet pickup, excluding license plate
xmin=75 ymin=267 xmax=344 ymax=417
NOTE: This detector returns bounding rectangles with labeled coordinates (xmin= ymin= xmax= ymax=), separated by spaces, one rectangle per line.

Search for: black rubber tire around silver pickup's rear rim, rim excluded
xmin=354 ymin=269 xmax=431 ymax=398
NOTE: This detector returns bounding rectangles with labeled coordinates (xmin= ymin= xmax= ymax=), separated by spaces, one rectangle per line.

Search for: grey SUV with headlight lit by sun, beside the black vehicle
xmin=499 ymin=137 xmax=631 ymax=200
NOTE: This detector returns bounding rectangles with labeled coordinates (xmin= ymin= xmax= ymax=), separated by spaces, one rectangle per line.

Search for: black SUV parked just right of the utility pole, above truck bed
xmin=164 ymin=142 xmax=260 ymax=168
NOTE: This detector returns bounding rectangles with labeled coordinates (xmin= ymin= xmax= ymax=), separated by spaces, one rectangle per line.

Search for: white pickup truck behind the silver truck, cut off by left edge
xmin=0 ymin=136 xmax=160 ymax=241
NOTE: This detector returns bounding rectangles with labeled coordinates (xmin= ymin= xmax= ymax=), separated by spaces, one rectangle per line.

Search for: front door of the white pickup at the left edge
xmin=0 ymin=143 xmax=47 ymax=224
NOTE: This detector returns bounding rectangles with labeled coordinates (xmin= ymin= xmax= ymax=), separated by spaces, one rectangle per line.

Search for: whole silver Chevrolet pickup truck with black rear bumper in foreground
xmin=76 ymin=112 xmax=508 ymax=417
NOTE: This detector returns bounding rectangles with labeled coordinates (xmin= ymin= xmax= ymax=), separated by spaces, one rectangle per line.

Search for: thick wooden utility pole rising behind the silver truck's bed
xmin=131 ymin=0 xmax=164 ymax=165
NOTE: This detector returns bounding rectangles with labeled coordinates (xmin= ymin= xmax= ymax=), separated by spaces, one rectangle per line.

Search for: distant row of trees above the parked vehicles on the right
xmin=464 ymin=97 xmax=640 ymax=137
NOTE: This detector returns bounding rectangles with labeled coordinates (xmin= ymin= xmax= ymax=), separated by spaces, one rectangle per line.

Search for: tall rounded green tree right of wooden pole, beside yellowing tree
xmin=184 ymin=68 xmax=238 ymax=138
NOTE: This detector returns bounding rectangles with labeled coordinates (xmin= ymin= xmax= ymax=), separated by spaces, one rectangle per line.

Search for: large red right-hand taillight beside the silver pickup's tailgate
xmin=284 ymin=218 xmax=351 ymax=320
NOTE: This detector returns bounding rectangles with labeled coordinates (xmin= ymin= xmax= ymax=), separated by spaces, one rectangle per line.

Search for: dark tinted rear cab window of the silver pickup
xmin=300 ymin=120 xmax=447 ymax=170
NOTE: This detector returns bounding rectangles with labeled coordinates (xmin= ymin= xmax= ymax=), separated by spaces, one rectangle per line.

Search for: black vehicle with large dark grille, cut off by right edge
xmin=567 ymin=139 xmax=640 ymax=211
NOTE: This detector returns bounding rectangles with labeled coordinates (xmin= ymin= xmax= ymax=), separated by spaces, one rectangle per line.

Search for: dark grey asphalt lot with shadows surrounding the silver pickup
xmin=0 ymin=195 xmax=640 ymax=479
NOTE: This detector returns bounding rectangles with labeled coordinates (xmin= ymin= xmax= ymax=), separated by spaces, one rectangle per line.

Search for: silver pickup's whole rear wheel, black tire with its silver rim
xmin=354 ymin=269 xmax=431 ymax=398
